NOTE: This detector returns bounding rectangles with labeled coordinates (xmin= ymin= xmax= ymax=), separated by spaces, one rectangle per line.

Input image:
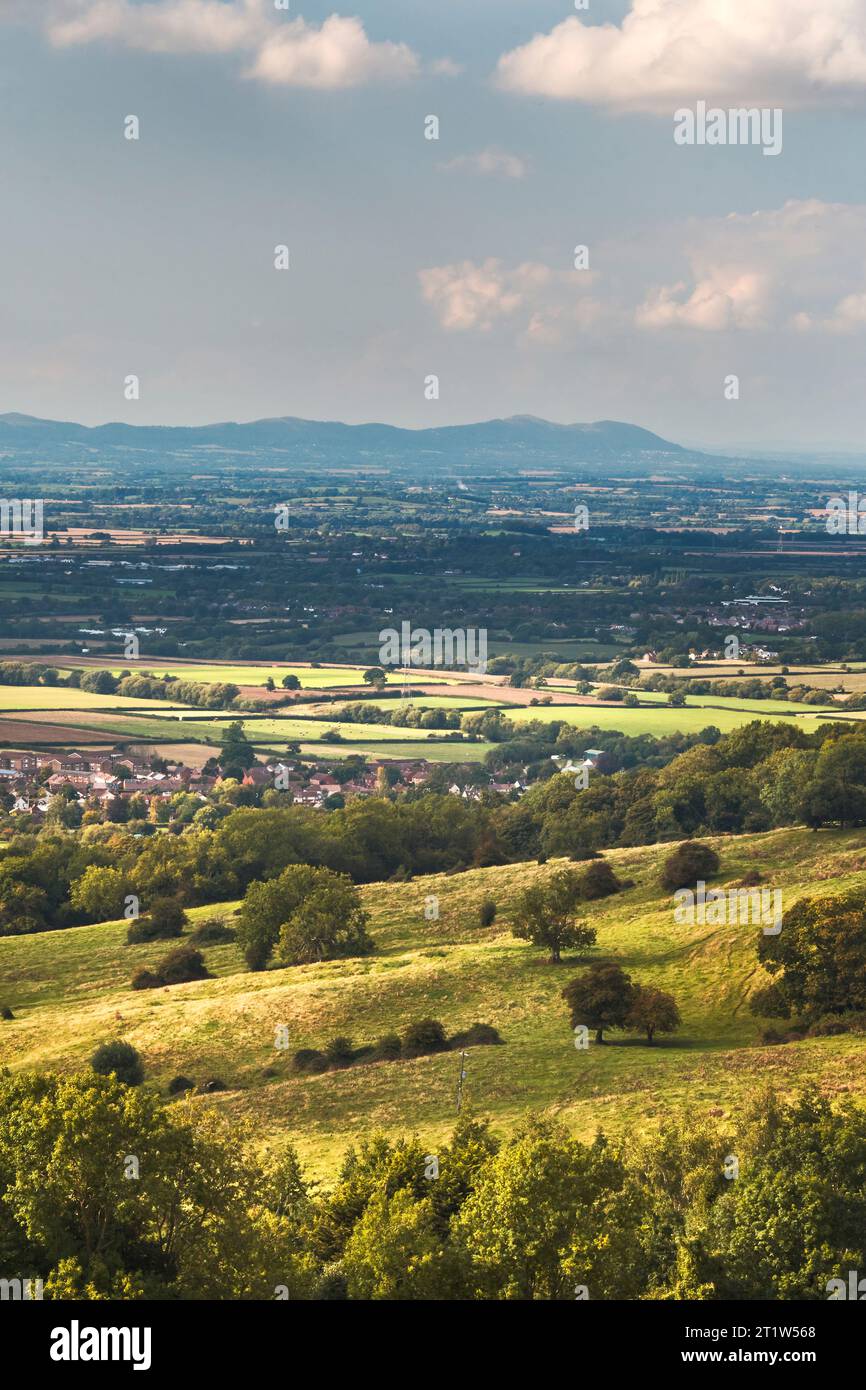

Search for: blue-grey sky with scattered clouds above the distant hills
xmin=0 ymin=0 xmax=866 ymax=449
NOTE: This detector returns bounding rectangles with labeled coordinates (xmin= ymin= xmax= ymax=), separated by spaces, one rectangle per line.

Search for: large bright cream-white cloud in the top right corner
xmin=496 ymin=0 xmax=866 ymax=114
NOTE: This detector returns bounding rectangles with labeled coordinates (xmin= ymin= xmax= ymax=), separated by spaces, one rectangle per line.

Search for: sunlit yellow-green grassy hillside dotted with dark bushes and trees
xmin=0 ymin=830 xmax=866 ymax=1175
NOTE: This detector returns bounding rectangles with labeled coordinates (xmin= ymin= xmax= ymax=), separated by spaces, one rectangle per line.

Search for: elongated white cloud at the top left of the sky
xmin=46 ymin=0 xmax=420 ymax=89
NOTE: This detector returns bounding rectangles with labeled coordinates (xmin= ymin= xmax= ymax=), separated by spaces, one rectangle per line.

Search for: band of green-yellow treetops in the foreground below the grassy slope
xmin=0 ymin=1055 xmax=866 ymax=1301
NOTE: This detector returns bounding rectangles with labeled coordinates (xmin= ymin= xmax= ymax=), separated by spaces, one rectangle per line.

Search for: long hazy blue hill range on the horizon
xmin=0 ymin=413 xmax=710 ymax=470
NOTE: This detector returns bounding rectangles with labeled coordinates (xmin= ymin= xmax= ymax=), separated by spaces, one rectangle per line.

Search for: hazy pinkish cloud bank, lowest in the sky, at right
xmin=418 ymin=199 xmax=866 ymax=346
